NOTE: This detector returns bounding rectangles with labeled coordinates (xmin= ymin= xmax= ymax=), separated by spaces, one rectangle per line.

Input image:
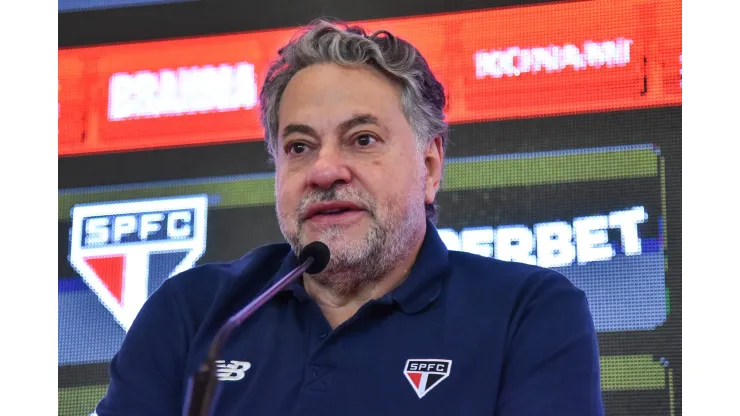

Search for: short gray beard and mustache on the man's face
xmin=278 ymin=188 xmax=426 ymax=296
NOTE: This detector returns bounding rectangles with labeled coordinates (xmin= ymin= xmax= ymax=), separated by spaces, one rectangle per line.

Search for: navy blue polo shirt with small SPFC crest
xmin=97 ymin=219 xmax=603 ymax=416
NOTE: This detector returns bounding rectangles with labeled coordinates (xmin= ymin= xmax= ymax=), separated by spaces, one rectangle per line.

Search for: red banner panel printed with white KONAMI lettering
xmin=442 ymin=2 xmax=647 ymax=121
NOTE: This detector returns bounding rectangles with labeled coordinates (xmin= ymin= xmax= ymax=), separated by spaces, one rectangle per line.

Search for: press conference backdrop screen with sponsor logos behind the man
xmin=58 ymin=0 xmax=681 ymax=415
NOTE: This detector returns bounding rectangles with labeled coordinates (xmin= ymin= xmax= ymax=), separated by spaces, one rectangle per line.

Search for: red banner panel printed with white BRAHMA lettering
xmin=93 ymin=31 xmax=292 ymax=153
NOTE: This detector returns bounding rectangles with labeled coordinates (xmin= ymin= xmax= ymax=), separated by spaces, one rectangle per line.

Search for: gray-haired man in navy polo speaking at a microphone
xmin=97 ymin=21 xmax=603 ymax=416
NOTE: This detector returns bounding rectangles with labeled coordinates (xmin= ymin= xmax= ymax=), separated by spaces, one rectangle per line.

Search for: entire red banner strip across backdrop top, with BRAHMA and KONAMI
xmin=59 ymin=0 xmax=681 ymax=155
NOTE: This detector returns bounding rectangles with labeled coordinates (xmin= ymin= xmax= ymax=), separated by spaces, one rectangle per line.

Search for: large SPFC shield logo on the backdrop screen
xmin=69 ymin=195 xmax=208 ymax=331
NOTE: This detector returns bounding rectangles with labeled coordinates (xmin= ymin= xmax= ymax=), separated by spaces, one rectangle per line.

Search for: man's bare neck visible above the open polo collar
xmin=303 ymin=234 xmax=424 ymax=328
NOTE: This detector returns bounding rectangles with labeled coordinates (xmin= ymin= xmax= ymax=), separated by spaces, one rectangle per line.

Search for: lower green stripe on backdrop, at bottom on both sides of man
xmin=59 ymin=355 xmax=666 ymax=416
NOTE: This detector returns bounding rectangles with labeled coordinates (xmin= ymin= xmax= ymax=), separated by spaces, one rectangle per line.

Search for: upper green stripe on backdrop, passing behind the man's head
xmin=59 ymin=148 xmax=658 ymax=220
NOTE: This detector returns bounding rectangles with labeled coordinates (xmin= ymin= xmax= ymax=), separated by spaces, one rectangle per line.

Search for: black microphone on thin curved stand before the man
xmin=182 ymin=241 xmax=330 ymax=416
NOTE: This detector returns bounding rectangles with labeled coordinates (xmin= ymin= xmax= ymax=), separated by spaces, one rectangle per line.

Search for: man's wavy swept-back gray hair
xmin=260 ymin=19 xmax=449 ymax=223
